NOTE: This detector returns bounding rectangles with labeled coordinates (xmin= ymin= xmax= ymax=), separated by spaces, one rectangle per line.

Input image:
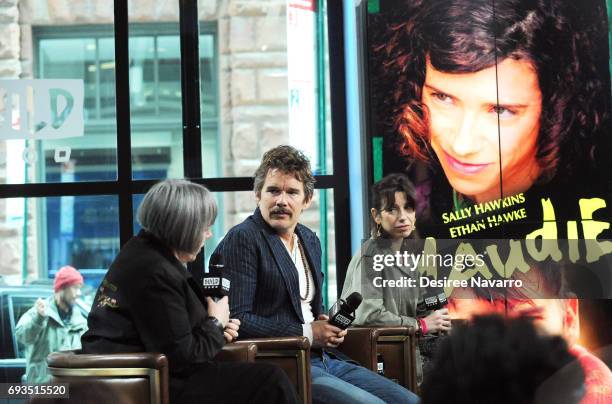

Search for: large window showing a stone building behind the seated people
xmin=0 ymin=0 xmax=350 ymax=312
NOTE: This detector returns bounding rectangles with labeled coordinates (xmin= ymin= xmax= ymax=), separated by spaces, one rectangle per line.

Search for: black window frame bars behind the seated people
xmin=0 ymin=0 xmax=351 ymax=294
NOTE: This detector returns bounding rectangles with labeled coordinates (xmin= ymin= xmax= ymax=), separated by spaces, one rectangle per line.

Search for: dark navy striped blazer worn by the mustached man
xmin=215 ymin=208 xmax=323 ymax=338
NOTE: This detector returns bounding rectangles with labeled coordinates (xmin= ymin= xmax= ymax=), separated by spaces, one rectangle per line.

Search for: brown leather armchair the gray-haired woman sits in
xmin=46 ymin=343 xmax=257 ymax=404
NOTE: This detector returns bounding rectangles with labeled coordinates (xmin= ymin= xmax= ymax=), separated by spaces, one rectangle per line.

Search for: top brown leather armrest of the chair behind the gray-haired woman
xmin=47 ymin=351 xmax=168 ymax=369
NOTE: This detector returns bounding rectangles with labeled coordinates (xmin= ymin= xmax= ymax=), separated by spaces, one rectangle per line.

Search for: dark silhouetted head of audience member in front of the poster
xmin=422 ymin=315 xmax=584 ymax=404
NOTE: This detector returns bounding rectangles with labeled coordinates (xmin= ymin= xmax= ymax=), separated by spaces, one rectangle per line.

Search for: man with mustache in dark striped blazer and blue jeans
xmin=215 ymin=146 xmax=417 ymax=403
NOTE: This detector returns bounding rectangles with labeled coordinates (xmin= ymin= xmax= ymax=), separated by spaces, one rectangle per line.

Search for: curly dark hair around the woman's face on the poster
xmin=371 ymin=0 xmax=609 ymax=182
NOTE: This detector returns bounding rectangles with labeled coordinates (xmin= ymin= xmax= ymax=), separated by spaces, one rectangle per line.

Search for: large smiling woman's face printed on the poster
xmin=422 ymin=59 xmax=542 ymax=202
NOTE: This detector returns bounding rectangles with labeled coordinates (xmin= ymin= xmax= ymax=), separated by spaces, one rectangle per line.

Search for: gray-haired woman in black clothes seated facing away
xmin=82 ymin=180 xmax=297 ymax=403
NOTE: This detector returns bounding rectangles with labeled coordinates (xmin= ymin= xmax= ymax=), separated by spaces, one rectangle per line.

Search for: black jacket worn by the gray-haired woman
xmin=82 ymin=232 xmax=224 ymax=378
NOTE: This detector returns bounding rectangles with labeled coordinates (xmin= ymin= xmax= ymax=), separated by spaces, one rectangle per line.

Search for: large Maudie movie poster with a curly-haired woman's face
xmin=367 ymin=0 xmax=612 ymax=370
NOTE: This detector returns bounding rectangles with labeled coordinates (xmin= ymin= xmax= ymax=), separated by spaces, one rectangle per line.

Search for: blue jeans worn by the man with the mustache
xmin=311 ymin=353 xmax=419 ymax=404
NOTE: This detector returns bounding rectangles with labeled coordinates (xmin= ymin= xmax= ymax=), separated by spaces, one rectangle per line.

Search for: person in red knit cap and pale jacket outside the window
xmin=15 ymin=266 xmax=87 ymax=383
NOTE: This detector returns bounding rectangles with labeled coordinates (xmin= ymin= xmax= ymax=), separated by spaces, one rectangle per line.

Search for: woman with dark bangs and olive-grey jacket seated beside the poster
xmin=342 ymin=174 xmax=451 ymax=384
